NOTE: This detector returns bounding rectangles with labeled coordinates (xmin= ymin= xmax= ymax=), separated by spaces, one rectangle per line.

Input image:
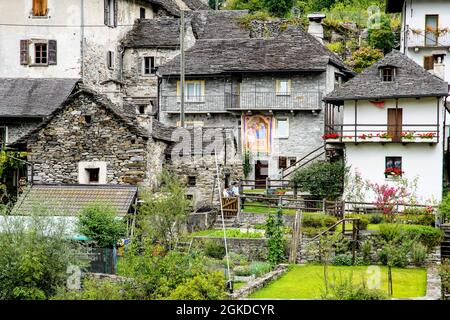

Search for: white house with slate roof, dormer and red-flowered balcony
xmin=324 ymin=50 xmax=448 ymax=203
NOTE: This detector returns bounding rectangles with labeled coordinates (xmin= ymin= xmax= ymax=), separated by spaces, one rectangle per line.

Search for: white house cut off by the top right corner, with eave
xmin=386 ymin=0 xmax=450 ymax=81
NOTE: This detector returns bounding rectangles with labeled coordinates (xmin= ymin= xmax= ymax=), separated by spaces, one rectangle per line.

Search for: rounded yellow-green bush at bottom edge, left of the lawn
xmin=169 ymin=272 xmax=226 ymax=300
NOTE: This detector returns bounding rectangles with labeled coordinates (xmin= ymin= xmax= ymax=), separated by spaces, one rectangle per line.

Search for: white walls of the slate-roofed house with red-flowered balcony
xmin=343 ymin=98 xmax=444 ymax=203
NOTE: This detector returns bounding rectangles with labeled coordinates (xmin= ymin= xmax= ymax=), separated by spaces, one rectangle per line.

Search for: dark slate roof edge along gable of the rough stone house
xmin=8 ymin=88 xmax=171 ymax=148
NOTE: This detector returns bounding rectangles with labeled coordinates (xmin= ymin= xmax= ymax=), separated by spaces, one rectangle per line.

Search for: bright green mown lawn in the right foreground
xmin=250 ymin=265 xmax=427 ymax=299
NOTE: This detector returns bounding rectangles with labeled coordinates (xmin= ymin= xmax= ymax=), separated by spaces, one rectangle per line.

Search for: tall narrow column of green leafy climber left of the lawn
xmin=266 ymin=210 xmax=286 ymax=265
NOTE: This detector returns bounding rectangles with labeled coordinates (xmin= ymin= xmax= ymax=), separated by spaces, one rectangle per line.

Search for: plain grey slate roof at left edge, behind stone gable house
xmin=0 ymin=78 xmax=79 ymax=118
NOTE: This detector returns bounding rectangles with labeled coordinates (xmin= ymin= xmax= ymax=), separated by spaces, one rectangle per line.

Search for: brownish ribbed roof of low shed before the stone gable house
xmin=12 ymin=184 xmax=138 ymax=216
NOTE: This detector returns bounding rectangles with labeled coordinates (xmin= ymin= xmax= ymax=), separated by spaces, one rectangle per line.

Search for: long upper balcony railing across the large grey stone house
xmin=161 ymin=91 xmax=322 ymax=113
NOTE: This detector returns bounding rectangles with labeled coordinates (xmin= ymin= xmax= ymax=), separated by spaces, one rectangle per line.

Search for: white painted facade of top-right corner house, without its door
xmin=401 ymin=0 xmax=450 ymax=82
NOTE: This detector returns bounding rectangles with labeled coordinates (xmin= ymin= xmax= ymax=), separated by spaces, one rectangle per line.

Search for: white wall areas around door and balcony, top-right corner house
xmin=401 ymin=0 xmax=450 ymax=81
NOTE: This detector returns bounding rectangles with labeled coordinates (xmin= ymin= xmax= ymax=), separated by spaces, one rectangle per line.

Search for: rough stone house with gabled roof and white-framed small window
xmin=11 ymin=89 xmax=171 ymax=187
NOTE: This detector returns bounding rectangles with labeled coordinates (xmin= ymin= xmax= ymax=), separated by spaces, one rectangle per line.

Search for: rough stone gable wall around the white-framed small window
xmin=28 ymin=93 xmax=164 ymax=185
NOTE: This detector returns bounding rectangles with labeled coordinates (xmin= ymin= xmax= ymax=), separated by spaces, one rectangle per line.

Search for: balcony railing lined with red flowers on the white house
xmin=323 ymin=124 xmax=439 ymax=143
